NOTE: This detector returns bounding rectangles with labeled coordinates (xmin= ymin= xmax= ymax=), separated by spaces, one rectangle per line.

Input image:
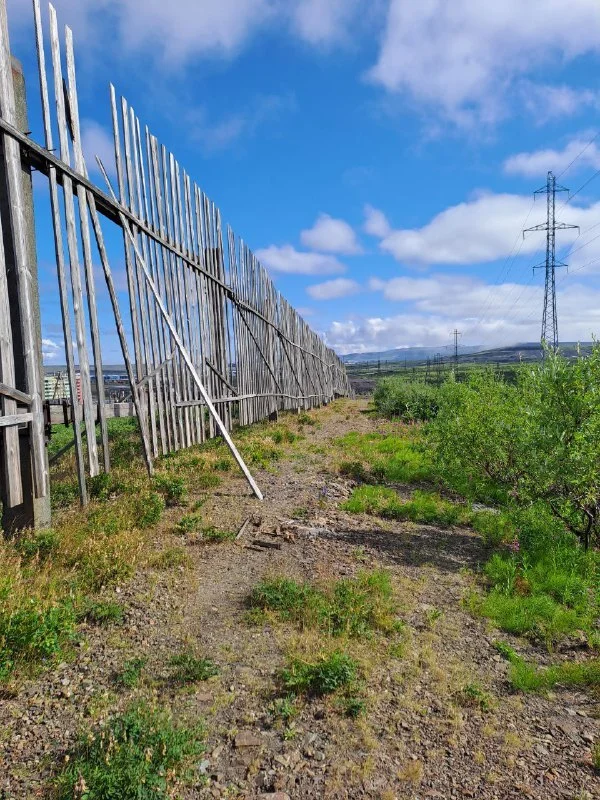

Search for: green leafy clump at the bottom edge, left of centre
xmin=56 ymin=704 xmax=204 ymax=800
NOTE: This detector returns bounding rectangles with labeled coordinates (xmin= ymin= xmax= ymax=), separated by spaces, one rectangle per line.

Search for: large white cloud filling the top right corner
xmin=369 ymin=0 xmax=600 ymax=123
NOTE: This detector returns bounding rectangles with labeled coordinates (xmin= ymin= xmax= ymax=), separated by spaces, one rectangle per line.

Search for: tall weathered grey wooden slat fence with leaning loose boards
xmin=0 ymin=0 xmax=349 ymax=503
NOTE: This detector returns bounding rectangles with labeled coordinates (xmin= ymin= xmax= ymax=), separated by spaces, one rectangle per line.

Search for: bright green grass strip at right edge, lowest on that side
xmin=496 ymin=642 xmax=600 ymax=692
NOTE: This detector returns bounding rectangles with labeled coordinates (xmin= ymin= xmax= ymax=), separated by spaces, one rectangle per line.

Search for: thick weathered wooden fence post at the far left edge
xmin=0 ymin=59 xmax=50 ymax=531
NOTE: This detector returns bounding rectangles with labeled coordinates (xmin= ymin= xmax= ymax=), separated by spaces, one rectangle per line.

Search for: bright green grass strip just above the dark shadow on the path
xmin=341 ymin=485 xmax=473 ymax=525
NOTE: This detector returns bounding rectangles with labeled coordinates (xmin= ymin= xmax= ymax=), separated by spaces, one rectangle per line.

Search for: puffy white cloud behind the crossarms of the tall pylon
xmin=380 ymin=193 xmax=600 ymax=265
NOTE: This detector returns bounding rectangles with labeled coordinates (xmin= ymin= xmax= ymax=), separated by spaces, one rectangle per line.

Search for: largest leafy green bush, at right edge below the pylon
xmin=430 ymin=344 xmax=600 ymax=547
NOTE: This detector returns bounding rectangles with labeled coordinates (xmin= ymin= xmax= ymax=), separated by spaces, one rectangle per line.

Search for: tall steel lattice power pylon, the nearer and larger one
xmin=523 ymin=172 xmax=579 ymax=350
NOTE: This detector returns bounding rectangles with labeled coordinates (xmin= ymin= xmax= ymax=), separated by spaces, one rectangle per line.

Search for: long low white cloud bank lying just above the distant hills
xmin=325 ymin=276 xmax=600 ymax=353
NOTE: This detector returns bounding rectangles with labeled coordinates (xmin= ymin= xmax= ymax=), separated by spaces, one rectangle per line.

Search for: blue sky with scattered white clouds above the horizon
xmin=8 ymin=0 xmax=600 ymax=363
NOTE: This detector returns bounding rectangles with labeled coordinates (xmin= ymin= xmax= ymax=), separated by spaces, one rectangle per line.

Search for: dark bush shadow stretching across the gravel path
xmin=319 ymin=526 xmax=487 ymax=572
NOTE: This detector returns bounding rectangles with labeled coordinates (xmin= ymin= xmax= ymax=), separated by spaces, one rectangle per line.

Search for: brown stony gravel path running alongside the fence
xmin=0 ymin=401 xmax=600 ymax=800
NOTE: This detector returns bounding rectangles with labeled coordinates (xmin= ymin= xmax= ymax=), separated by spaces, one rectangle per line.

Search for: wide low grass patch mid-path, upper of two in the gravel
xmin=249 ymin=570 xmax=400 ymax=638
